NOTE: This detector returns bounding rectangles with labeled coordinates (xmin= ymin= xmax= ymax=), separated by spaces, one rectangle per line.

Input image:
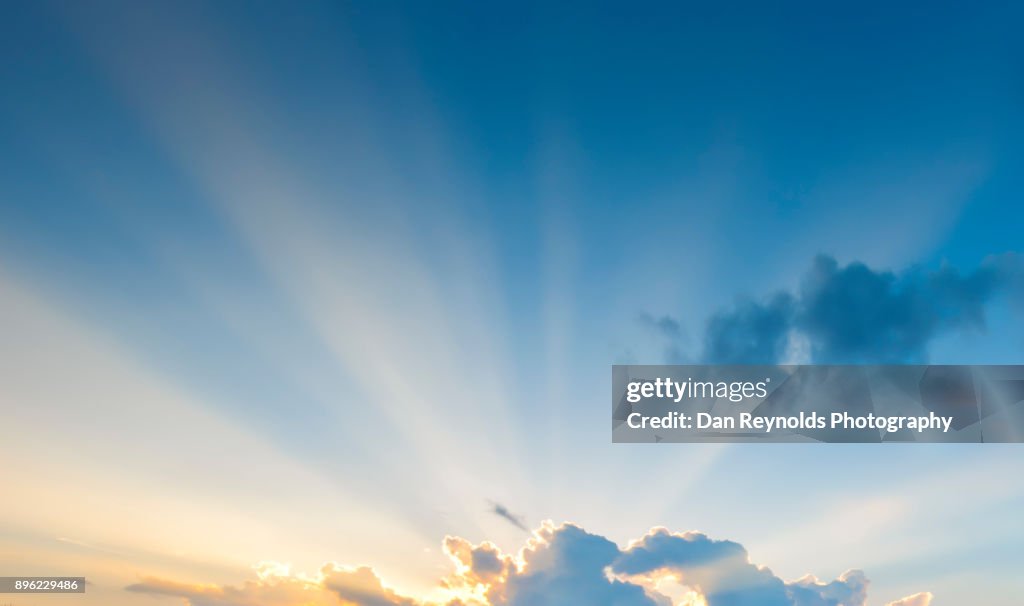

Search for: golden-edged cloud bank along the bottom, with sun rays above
xmin=126 ymin=522 xmax=932 ymax=606
